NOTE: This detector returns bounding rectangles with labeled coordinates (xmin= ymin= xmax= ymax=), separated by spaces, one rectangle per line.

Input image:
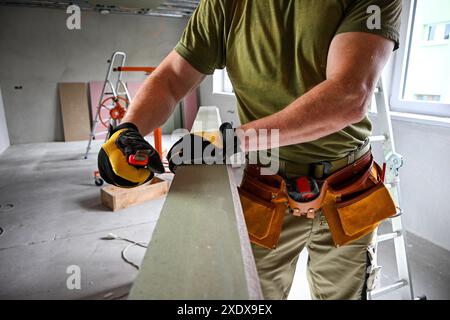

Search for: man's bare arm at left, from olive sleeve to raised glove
xmin=122 ymin=51 xmax=205 ymax=135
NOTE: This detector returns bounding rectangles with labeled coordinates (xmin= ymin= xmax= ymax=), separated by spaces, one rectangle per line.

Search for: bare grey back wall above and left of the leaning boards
xmin=0 ymin=7 xmax=187 ymax=144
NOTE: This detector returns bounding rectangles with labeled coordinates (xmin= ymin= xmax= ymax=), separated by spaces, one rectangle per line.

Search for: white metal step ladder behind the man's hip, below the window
xmin=367 ymin=80 xmax=414 ymax=300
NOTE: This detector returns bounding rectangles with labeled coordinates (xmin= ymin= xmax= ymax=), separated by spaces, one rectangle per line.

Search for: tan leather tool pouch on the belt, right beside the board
xmin=238 ymin=166 xmax=287 ymax=249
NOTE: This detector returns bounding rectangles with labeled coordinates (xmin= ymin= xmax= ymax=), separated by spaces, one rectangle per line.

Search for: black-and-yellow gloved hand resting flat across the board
xmin=167 ymin=122 xmax=241 ymax=173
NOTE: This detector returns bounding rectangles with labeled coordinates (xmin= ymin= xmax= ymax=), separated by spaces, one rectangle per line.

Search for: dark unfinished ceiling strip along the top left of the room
xmin=0 ymin=0 xmax=200 ymax=18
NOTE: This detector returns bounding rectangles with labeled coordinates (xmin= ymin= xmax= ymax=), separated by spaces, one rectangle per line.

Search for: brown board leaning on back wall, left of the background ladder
xmin=58 ymin=83 xmax=90 ymax=141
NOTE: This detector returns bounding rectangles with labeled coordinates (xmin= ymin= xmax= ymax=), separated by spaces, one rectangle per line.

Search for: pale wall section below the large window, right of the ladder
xmin=386 ymin=120 xmax=450 ymax=250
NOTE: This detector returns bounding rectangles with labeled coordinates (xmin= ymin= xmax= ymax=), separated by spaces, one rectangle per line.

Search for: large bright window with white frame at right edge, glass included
xmin=391 ymin=0 xmax=450 ymax=117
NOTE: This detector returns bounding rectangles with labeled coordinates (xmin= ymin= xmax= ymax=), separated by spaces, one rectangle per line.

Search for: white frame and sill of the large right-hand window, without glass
xmin=389 ymin=0 xmax=450 ymax=118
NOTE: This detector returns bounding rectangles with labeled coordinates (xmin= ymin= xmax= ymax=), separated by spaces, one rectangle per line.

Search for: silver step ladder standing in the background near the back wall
xmin=84 ymin=51 xmax=131 ymax=159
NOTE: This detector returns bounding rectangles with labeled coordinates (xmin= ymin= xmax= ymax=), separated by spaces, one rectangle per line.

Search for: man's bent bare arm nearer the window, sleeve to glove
xmin=238 ymin=32 xmax=394 ymax=151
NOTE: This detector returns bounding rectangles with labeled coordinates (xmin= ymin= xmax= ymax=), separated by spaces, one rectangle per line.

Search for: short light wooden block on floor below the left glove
xmin=100 ymin=177 xmax=169 ymax=211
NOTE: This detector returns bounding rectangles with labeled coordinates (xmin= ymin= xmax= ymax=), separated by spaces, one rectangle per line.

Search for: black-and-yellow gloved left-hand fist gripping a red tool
xmin=98 ymin=123 xmax=164 ymax=188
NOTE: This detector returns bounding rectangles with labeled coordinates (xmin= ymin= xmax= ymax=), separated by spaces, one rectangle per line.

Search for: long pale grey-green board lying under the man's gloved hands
xmin=129 ymin=107 xmax=262 ymax=299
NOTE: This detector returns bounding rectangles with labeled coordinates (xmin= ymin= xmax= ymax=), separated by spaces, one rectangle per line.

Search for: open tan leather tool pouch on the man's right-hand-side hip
xmin=323 ymin=152 xmax=396 ymax=247
